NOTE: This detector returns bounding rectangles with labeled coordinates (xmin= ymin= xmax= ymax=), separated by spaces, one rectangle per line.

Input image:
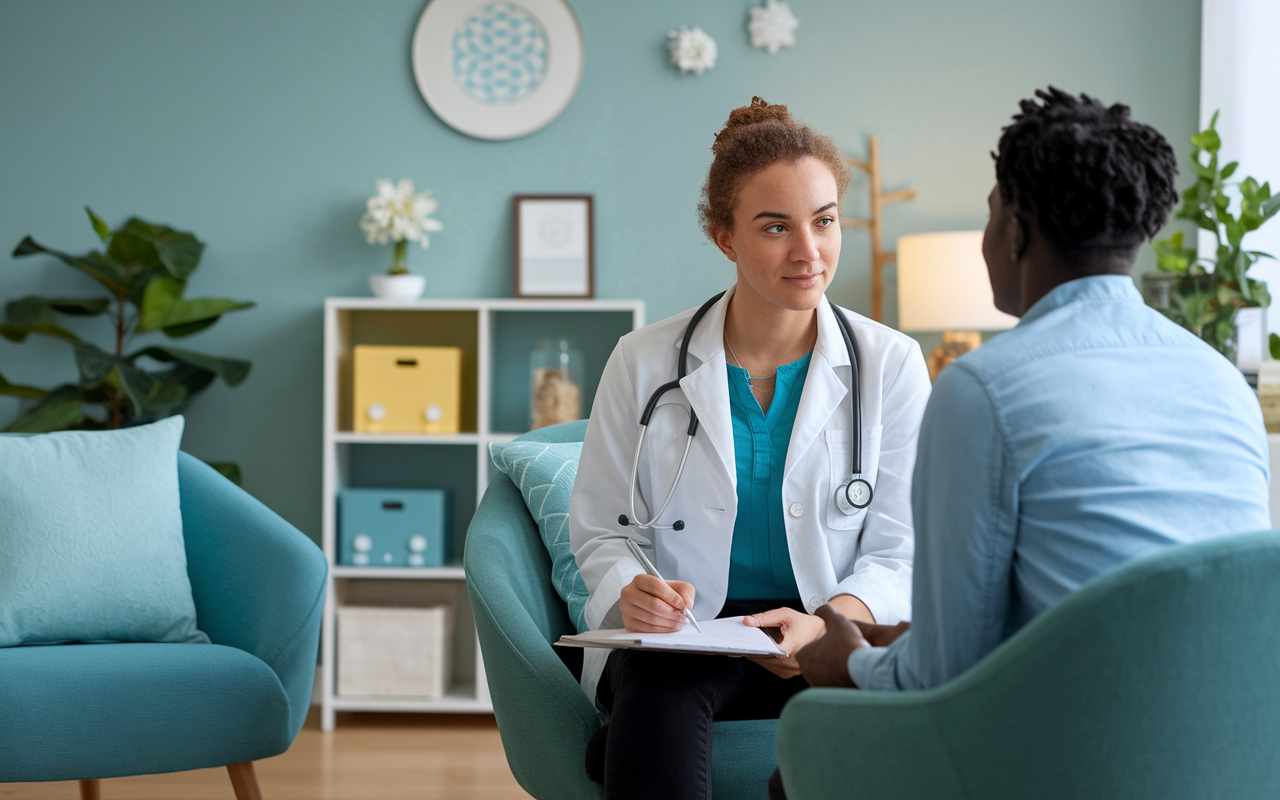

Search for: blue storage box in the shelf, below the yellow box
xmin=338 ymin=489 xmax=453 ymax=567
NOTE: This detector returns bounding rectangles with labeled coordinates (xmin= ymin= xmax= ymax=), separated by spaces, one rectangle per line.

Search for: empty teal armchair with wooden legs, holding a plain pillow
xmin=0 ymin=453 xmax=328 ymax=800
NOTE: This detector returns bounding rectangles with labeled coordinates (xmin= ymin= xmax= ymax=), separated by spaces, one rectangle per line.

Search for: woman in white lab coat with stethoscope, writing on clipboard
xmin=570 ymin=97 xmax=929 ymax=800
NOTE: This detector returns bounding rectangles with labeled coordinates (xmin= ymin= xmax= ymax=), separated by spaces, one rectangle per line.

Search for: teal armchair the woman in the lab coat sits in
xmin=463 ymin=421 xmax=778 ymax=800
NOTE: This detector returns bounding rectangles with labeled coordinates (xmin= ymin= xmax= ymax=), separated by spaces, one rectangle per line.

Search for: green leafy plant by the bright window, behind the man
xmin=1156 ymin=113 xmax=1280 ymax=361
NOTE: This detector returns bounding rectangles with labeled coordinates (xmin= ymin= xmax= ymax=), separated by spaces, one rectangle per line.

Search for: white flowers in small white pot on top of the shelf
xmin=360 ymin=178 xmax=442 ymax=300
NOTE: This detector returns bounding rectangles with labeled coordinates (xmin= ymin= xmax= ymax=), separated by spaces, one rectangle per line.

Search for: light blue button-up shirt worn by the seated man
xmin=849 ymin=275 xmax=1271 ymax=690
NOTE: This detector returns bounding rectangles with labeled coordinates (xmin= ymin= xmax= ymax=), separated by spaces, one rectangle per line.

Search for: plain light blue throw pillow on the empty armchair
xmin=0 ymin=417 xmax=209 ymax=646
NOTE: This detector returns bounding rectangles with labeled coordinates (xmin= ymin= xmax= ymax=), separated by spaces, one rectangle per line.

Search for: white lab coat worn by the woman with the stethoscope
xmin=570 ymin=284 xmax=929 ymax=701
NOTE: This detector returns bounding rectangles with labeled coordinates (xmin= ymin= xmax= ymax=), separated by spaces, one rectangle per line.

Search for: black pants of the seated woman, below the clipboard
xmin=586 ymin=600 xmax=809 ymax=800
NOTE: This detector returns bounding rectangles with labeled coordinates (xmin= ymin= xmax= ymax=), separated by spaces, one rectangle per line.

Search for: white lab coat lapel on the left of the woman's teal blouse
xmin=676 ymin=284 xmax=737 ymax=488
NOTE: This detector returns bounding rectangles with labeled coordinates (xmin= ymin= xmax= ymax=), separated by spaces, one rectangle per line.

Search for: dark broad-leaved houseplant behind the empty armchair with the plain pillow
xmin=0 ymin=207 xmax=253 ymax=480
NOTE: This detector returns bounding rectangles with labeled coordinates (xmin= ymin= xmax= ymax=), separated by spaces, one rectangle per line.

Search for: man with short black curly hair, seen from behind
xmin=799 ymin=90 xmax=1271 ymax=690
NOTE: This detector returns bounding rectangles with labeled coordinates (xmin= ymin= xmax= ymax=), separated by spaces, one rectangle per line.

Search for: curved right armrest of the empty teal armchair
xmin=178 ymin=453 xmax=328 ymax=736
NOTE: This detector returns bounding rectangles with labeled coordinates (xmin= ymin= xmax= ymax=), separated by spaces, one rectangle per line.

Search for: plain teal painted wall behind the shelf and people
xmin=0 ymin=0 xmax=1199 ymax=536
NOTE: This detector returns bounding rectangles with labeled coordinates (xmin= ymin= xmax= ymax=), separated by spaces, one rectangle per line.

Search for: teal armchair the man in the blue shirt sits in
xmin=778 ymin=529 xmax=1280 ymax=800
